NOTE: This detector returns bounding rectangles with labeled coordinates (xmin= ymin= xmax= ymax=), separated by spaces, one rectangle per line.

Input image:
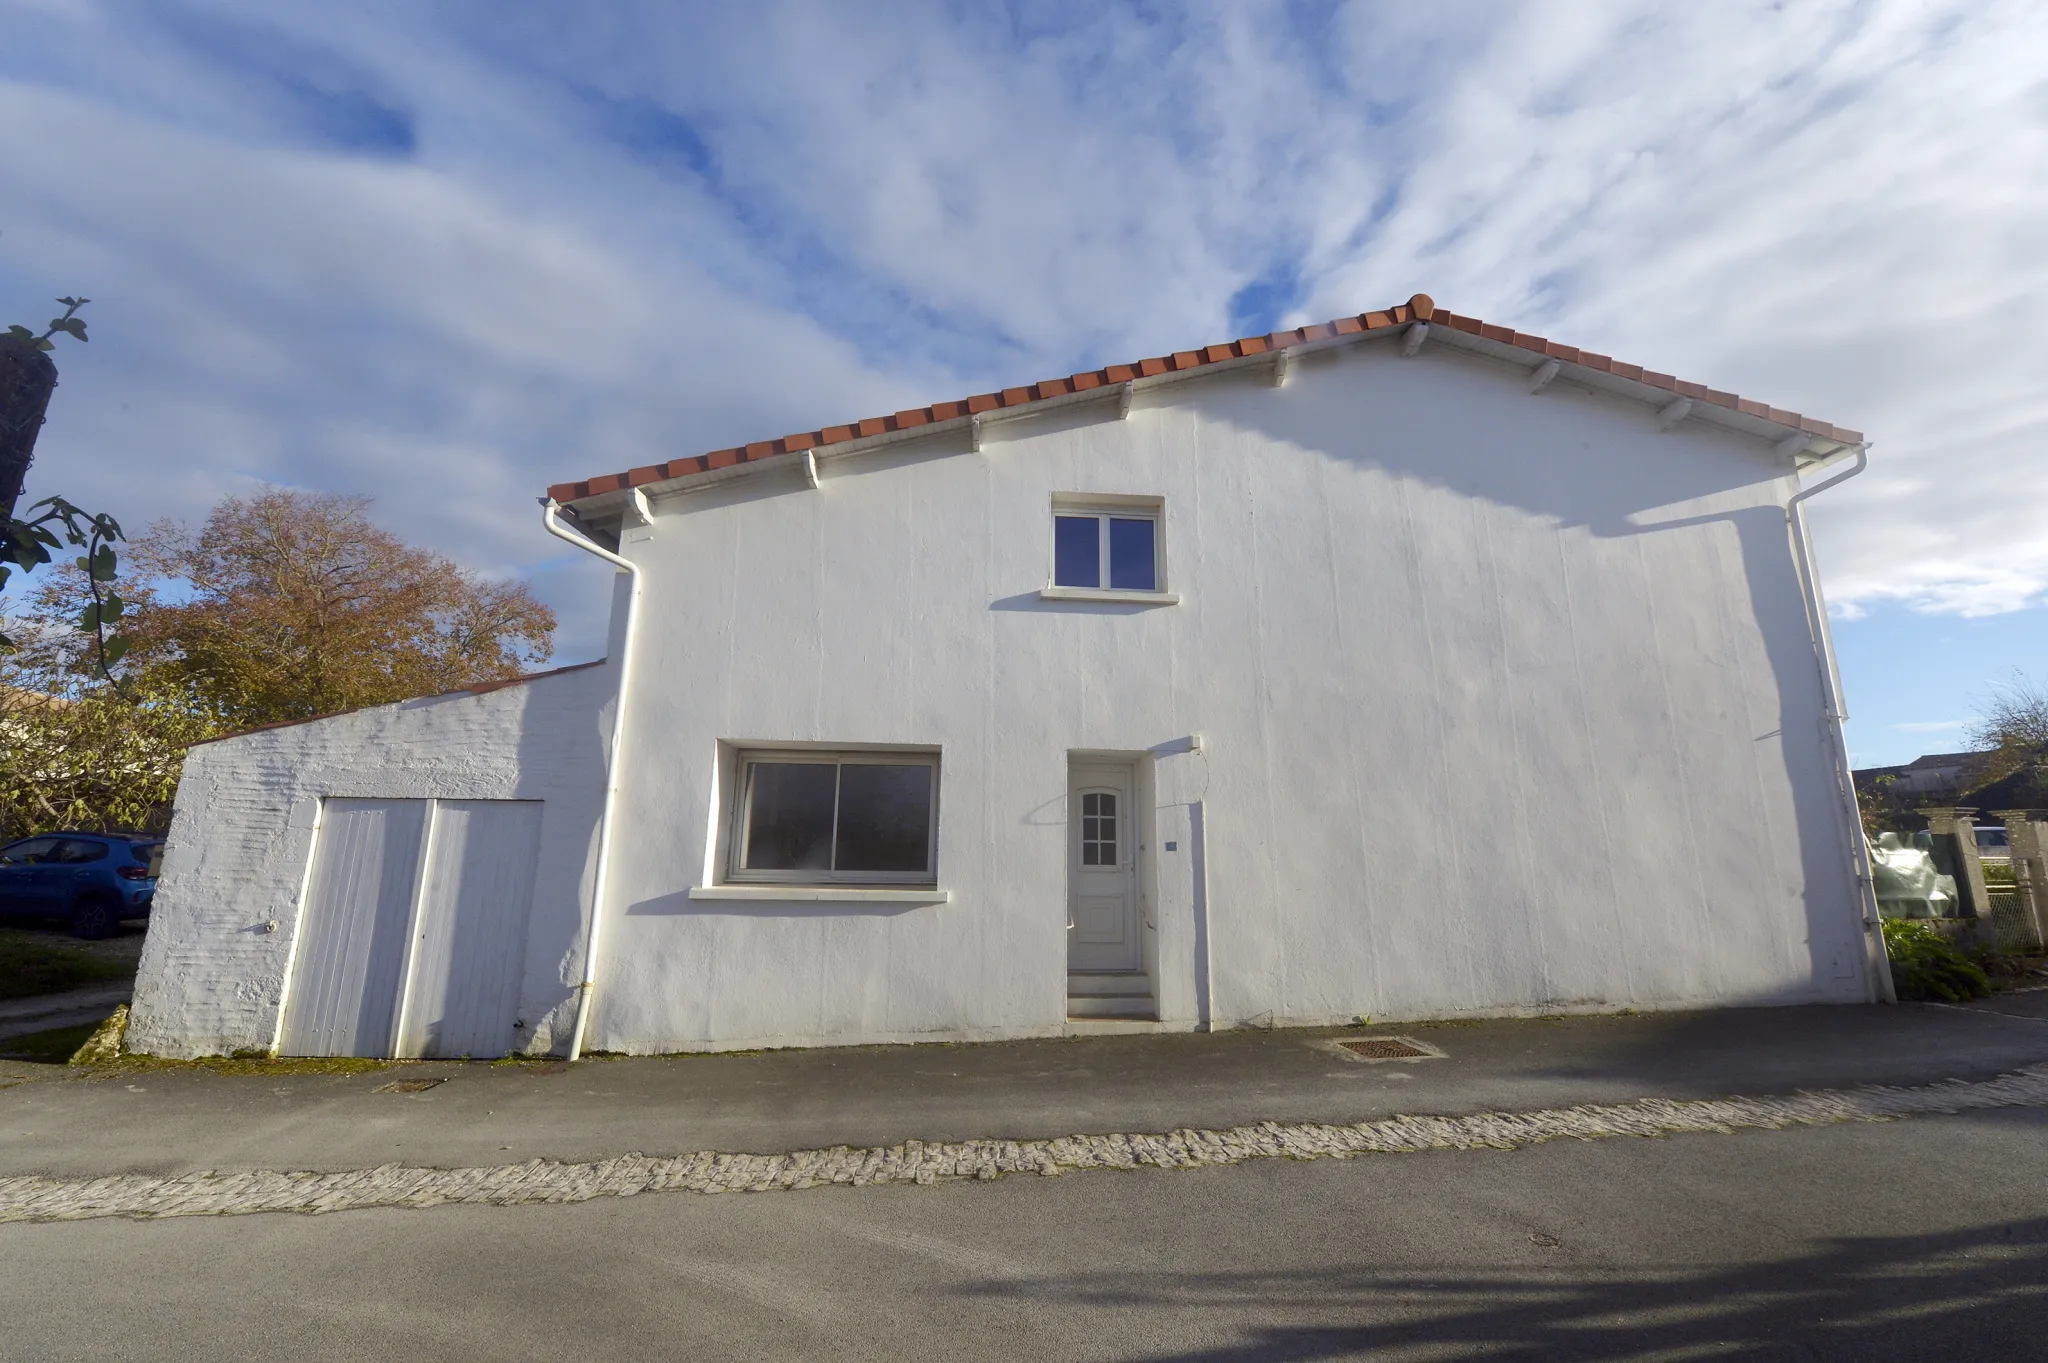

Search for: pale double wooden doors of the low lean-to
xmin=279 ymin=798 xmax=541 ymax=1058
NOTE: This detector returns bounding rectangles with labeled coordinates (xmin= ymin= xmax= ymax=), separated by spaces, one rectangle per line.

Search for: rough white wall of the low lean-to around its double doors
xmin=127 ymin=667 xmax=614 ymax=1056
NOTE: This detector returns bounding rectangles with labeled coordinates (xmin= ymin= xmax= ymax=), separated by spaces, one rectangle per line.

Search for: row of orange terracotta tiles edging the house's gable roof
xmin=547 ymin=293 xmax=1862 ymax=501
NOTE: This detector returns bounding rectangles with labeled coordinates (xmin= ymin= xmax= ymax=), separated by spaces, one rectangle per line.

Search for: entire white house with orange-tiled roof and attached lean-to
xmin=129 ymin=295 xmax=1888 ymax=1056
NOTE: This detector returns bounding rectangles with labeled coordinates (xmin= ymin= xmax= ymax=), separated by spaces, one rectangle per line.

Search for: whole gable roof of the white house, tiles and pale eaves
xmin=547 ymin=293 xmax=1864 ymax=510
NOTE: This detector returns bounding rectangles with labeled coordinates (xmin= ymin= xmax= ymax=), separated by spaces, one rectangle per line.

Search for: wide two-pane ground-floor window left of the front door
xmin=727 ymin=749 xmax=938 ymax=886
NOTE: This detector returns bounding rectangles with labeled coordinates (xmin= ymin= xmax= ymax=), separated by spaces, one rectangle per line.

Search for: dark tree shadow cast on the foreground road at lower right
xmin=975 ymin=1220 xmax=2048 ymax=1363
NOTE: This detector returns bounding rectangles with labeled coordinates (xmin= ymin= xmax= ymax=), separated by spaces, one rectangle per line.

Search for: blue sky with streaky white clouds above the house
xmin=0 ymin=0 xmax=2048 ymax=765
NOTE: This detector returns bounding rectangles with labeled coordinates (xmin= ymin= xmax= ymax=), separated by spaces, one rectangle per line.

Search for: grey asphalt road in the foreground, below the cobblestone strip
xmin=0 ymin=1109 xmax=2048 ymax=1363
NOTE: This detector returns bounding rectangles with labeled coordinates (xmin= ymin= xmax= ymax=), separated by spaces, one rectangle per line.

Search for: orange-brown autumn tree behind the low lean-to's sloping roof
xmin=127 ymin=487 xmax=555 ymax=727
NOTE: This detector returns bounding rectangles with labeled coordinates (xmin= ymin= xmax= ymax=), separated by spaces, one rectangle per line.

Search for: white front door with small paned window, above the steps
xmin=1067 ymin=761 xmax=1145 ymax=972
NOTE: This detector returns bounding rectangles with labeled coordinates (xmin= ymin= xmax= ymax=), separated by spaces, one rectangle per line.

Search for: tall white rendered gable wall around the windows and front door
xmin=590 ymin=331 xmax=1870 ymax=1052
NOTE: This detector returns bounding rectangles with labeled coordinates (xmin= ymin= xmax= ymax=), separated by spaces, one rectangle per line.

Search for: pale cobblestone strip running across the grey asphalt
xmin=0 ymin=1068 xmax=2048 ymax=1222
